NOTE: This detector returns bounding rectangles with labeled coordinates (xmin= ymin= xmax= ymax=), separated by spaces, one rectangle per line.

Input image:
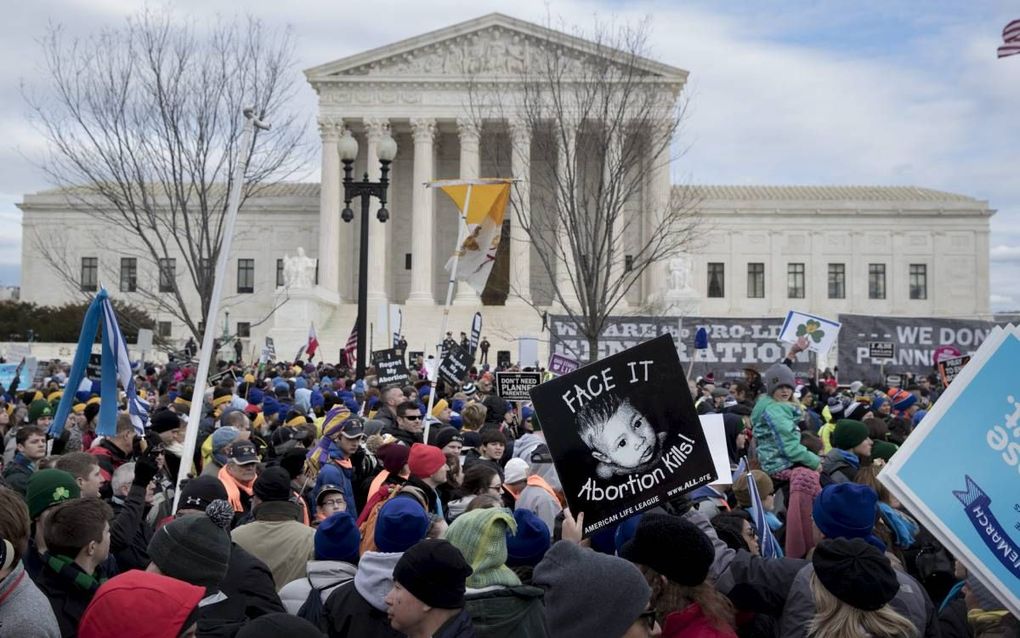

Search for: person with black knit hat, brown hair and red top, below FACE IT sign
xmin=620 ymin=512 xmax=735 ymax=638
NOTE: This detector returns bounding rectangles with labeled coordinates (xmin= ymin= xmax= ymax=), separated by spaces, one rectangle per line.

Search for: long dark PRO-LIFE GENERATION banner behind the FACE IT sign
xmin=549 ymin=315 xmax=808 ymax=379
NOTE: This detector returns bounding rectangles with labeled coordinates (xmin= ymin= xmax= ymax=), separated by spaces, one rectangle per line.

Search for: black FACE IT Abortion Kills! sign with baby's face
xmin=531 ymin=335 xmax=716 ymax=536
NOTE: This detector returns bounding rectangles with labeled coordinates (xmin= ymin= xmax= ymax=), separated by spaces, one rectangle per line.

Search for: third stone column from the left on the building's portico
xmin=407 ymin=117 xmax=436 ymax=305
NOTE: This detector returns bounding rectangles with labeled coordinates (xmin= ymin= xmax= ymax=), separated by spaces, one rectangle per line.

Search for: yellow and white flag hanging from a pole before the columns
xmin=434 ymin=179 xmax=512 ymax=294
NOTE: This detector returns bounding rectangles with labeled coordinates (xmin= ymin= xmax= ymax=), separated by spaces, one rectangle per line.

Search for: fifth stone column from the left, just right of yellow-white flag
xmin=507 ymin=118 xmax=531 ymax=305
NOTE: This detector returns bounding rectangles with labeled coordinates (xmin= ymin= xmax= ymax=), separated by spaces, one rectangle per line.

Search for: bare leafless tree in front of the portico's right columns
xmin=467 ymin=17 xmax=698 ymax=360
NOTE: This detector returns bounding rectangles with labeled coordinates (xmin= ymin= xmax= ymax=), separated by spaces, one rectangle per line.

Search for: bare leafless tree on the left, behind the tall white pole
xmin=24 ymin=9 xmax=310 ymax=339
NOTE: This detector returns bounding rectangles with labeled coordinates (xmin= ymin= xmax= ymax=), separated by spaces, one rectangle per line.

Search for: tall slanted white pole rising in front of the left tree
xmin=172 ymin=108 xmax=269 ymax=512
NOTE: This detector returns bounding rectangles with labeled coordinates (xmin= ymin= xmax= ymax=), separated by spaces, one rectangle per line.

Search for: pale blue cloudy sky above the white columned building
xmin=0 ymin=0 xmax=1020 ymax=310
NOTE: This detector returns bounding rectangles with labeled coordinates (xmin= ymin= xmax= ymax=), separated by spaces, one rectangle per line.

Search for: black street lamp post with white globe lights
xmin=338 ymin=131 xmax=397 ymax=379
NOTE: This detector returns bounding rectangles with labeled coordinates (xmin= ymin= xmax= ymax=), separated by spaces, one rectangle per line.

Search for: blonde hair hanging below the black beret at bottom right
xmin=808 ymin=573 xmax=918 ymax=638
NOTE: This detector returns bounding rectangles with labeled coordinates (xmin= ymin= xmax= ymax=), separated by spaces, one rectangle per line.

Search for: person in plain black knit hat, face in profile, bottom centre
xmin=386 ymin=539 xmax=473 ymax=638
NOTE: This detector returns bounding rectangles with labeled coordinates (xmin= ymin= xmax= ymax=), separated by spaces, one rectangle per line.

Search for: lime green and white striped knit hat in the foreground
xmin=445 ymin=507 xmax=520 ymax=589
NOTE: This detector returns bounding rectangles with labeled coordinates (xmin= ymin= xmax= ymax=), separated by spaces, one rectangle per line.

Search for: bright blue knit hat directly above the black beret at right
xmin=811 ymin=483 xmax=885 ymax=551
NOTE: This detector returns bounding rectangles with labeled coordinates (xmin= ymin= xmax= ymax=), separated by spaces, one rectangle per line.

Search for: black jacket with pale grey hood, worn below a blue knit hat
xmin=326 ymin=551 xmax=404 ymax=638
